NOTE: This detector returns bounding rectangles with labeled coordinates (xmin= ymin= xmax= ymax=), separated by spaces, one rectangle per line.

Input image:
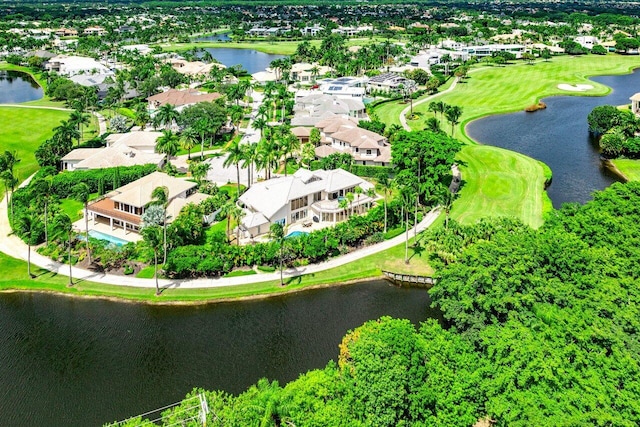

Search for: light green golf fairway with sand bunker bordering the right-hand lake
xmin=375 ymin=54 xmax=640 ymax=227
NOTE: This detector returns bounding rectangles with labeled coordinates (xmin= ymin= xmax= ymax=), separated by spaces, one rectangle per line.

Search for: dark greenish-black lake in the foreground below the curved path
xmin=0 ymin=281 xmax=438 ymax=426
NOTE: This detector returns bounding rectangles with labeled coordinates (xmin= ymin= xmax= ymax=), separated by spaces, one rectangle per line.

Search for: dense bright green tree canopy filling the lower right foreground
xmin=116 ymin=183 xmax=640 ymax=426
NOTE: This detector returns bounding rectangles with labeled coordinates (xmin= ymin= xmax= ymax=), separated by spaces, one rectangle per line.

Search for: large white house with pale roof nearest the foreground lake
xmin=238 ymin=169 xmax=376 ymax=238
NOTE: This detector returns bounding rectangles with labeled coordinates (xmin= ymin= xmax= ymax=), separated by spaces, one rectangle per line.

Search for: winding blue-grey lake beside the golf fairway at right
xmin=466 ymin=71 xmax=640 ymax=208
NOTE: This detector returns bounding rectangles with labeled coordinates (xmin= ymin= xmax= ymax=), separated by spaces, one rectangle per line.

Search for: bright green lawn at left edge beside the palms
xmin=0 ymin=107 xmax=69 ymax=192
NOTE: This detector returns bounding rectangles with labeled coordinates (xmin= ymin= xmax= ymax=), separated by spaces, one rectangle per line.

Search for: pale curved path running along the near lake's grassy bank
xmin=0 ymin=191 xmax=440 ymax=289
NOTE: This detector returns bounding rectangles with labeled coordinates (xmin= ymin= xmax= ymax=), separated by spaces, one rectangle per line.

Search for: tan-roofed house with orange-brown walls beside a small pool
xmin=88 ymin=172 xmax=209 ymax=233
